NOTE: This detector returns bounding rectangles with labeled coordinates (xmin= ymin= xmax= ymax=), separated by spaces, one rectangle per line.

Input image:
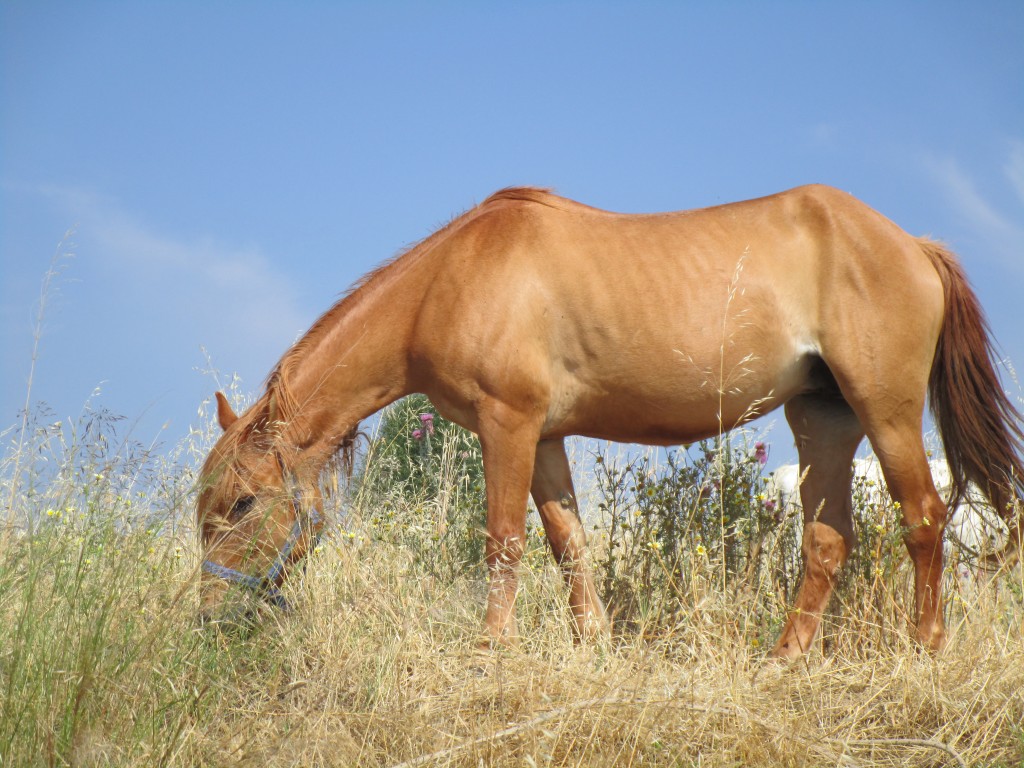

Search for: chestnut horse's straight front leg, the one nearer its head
xmin=480 ymin=406 xmax=539 ymax=645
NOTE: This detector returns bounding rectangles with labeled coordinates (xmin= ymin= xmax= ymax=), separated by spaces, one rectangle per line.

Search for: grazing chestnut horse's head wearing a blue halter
xmin=197 ymin=392 xmax=324 ymax=621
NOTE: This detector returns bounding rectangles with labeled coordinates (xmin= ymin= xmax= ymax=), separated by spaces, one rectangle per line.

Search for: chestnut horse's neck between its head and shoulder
xmin=283 ymin=292 xmax=413 ymax=466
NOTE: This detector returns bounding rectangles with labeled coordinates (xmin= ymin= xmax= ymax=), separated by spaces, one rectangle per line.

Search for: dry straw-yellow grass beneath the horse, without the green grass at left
xmin=163 ymin=536 xmax=1024 ymax=766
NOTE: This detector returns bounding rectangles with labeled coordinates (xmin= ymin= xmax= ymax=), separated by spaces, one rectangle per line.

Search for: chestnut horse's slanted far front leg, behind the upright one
xmin=531 ymin=439 xmax=608 ymax=639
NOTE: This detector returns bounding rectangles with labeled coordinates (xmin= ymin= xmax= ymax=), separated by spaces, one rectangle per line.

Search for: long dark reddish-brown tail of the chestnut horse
xmin=918 ymin=239 xmax=1024 ymax=550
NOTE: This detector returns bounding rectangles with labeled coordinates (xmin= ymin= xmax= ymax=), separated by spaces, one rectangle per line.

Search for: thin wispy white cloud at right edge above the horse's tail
xmin=925 ymin=142 xmax=1024 ymax=274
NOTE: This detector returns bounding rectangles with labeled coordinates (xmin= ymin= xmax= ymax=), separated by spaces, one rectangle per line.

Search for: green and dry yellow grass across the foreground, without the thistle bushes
xmin=0 ymin=409 xmax=1024 ymax=767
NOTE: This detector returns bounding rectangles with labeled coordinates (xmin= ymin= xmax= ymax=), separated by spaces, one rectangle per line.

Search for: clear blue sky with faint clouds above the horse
xmin=0 ymin=0 xmax=1024 ymax=462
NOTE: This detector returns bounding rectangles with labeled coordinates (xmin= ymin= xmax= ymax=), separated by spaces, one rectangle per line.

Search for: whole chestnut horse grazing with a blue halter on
xmin=198 ymin=186 xmax=1024 ymax=657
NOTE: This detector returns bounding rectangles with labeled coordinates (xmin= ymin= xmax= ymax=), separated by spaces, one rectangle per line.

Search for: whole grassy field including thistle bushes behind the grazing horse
xmin=0 ymin=399 xmax=1024 ymax=766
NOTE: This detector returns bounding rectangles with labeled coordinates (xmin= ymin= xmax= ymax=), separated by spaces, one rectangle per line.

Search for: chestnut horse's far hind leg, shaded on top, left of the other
xmin=773 ymin=393 xmax=864 ymax=658
